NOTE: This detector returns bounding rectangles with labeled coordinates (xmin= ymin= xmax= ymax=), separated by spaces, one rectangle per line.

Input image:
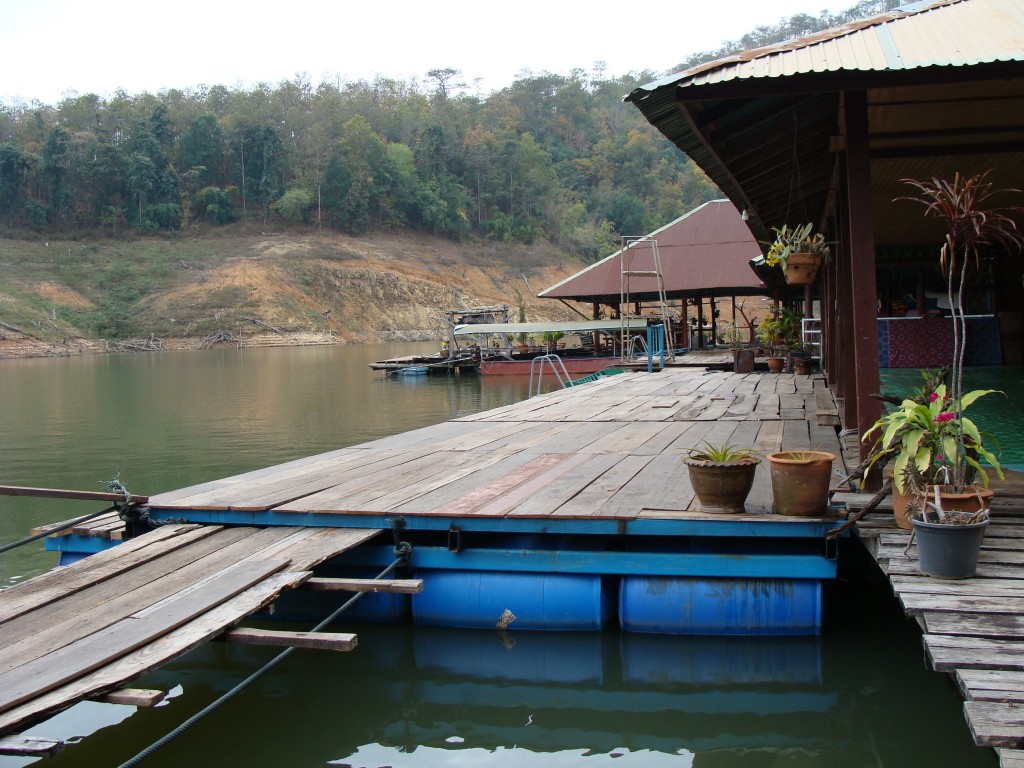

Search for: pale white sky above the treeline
xmin=0 ymin=0 xmax=855 ymax=104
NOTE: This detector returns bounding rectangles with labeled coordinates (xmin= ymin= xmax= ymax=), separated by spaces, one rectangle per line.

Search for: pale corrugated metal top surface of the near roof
xmin=627 ymin=0 xmax=1024 ymax=96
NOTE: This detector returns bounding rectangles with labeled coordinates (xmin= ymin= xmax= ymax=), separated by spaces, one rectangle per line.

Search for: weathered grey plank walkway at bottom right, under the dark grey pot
xmin=857 ymin=472 xmax=1024 ymax=768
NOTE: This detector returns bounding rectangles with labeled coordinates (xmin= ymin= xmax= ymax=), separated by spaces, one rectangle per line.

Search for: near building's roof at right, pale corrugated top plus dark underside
xmin=627 ymin=0 xmax=1024 ymax=246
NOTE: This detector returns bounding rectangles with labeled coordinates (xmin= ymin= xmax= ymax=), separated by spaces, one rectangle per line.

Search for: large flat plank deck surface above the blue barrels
xmin=150 ymin=369 xmax=842 ymax=524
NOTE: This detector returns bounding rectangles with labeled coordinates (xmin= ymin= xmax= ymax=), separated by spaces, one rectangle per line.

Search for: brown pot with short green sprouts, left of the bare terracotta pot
xmin=683 ymin=440 xmax=761 ymax=514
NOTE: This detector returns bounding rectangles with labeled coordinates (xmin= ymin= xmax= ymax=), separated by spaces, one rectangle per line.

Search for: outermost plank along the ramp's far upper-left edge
xmin=0 ymin=525 xmax=214 ymax=625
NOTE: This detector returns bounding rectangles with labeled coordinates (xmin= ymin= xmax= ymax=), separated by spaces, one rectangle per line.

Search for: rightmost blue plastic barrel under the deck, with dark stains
xmin=618 ymin=577 xmax=822 ymax=635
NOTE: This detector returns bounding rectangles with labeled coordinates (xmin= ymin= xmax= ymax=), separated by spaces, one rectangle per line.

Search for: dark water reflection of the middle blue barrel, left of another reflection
xmin=413 ymin=627 xmax=604 ymax=685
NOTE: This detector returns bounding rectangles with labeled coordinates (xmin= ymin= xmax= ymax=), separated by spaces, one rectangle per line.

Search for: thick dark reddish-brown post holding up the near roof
xmin=844 ymin=91 xmax=882 ymax=483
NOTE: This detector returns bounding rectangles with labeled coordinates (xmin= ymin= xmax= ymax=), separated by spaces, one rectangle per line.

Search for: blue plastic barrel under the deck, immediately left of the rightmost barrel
xmin=413 ymin=570 xmax=612 ymax=631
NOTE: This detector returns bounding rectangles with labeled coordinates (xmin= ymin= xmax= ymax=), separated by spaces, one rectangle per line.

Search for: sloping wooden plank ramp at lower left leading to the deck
xmin=0 ymin=524 xmax=380 ymax=735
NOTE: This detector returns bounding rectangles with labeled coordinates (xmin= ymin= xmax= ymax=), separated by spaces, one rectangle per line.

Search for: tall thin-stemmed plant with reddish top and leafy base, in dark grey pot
xmin=888 ymin=170 xmax=1024 ymax=579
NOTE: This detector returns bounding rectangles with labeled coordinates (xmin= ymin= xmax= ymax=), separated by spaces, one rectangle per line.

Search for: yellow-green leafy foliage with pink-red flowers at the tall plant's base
xmin=864 ymin=384 xmax=1005 ymax=494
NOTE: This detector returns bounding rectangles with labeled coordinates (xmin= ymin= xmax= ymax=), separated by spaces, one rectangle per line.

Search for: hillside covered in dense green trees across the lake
xmin=0 ymin=0 xmax=895 ymax=352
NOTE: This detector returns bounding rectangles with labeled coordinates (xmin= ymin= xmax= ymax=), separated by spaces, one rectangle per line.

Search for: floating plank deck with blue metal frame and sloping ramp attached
xmin=0 ymin=368 xmax=842 ymax=753
